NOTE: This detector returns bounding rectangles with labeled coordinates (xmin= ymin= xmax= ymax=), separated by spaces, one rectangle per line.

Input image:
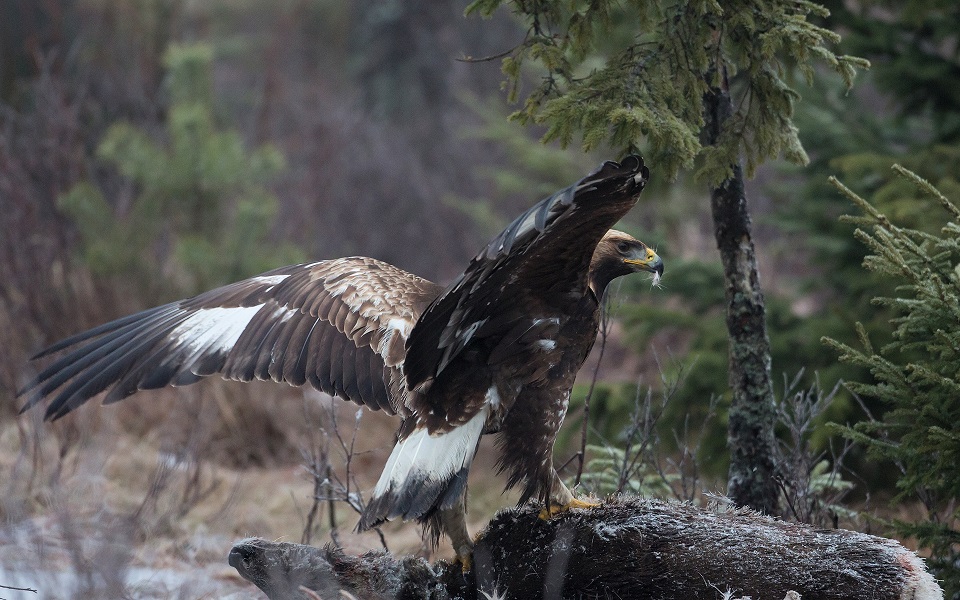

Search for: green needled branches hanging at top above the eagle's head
xmin=467 ymin=0 xmax=869 ymax=186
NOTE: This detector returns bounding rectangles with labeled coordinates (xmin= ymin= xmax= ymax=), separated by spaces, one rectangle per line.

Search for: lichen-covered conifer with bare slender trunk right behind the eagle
xmin=467 ymin=0 xmax=866 ymax=513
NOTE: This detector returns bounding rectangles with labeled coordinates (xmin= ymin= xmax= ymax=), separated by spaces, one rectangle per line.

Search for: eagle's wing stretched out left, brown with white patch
xmin=18 ymin=257 xmax=442 ymax=419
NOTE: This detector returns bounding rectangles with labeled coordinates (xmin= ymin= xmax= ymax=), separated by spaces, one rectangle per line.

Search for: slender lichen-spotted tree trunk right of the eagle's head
xmin=704 ymin=67 xmax=779 ymax=515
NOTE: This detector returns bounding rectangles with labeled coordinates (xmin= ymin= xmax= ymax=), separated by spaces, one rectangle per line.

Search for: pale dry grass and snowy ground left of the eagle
xmin=0 ymin=381 xmax=515 ymax=598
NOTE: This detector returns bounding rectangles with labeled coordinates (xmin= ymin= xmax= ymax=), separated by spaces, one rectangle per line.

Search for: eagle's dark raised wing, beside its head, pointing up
xmin=404 ymin=156 xmax=650 ymax=392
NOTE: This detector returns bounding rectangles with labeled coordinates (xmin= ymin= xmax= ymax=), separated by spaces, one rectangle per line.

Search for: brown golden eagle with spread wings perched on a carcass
xmin=19 ymin=156 xmax=663 ymax=560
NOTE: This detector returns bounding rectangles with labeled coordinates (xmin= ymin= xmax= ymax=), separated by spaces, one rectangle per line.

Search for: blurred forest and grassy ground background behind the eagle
xmin=0 ymin=0 xmax=960 ymax=597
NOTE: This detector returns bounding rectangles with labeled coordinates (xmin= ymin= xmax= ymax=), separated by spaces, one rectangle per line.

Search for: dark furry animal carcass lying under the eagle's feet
xmin=230 ymin=498 xmax=943 ymax=600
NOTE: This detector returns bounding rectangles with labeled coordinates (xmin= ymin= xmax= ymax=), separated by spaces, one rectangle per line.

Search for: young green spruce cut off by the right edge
xmin=824 ymin=166 xmax=960 ymax=597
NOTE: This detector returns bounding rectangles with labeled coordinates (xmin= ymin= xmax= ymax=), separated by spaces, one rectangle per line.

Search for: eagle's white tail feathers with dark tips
xmin=357 ymin=406 xmax=490 ymax=531
